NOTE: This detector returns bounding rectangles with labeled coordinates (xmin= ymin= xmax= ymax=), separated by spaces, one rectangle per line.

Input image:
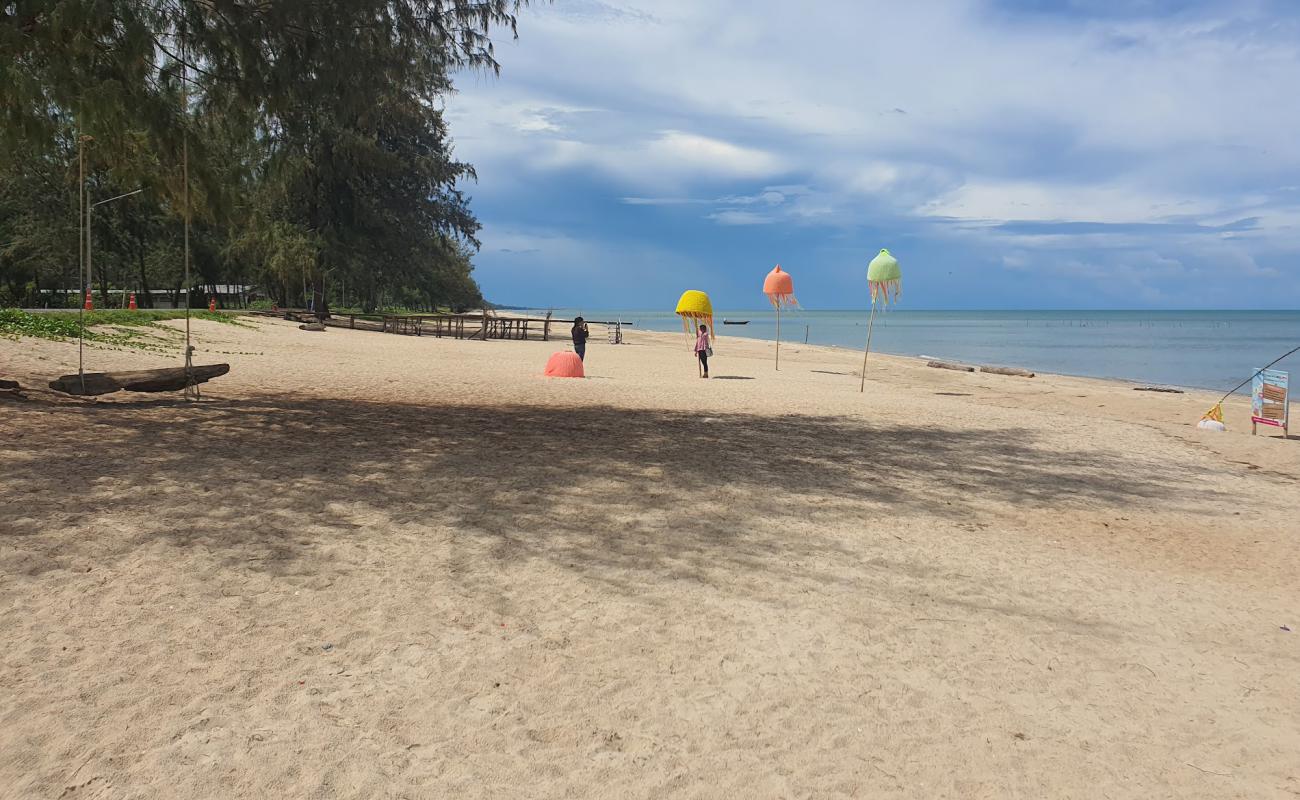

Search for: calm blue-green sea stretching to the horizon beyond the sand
xmin=533 ymin=308 xmax=1300 ymax=393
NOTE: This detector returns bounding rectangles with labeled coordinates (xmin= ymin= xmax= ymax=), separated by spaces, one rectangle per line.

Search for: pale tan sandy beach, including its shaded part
xmin=0 ymin=320 xmax=1300 ymax=799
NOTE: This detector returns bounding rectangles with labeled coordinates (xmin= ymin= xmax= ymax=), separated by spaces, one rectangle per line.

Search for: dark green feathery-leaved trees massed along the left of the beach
xmin=0 ymin=0 xmax=523 ymax=308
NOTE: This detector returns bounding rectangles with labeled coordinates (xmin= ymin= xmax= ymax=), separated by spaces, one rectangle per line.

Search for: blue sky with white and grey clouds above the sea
xmin=447 ymin=0 xmax=1300 ymax=308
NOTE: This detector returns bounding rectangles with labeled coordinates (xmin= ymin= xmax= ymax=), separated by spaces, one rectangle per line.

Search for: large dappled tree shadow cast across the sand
xmin=0 ymin=397 xmax=1209 ymax=600
